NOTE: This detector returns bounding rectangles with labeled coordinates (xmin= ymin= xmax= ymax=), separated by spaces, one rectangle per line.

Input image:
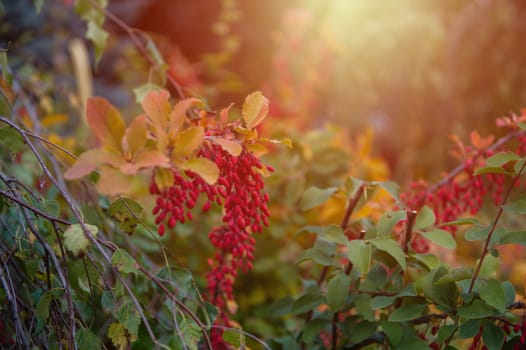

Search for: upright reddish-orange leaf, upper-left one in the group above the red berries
xmin=86 ymin=97 xmax=125 ymax=150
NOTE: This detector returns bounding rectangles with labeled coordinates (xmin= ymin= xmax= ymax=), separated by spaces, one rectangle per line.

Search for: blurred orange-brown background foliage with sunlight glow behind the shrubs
xmin=0 ymin=0 xmax=526 ymax=344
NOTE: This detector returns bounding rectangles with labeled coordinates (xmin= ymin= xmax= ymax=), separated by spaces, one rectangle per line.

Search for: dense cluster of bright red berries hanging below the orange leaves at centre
xmin=150 ymin=145 xmax=273 ymax=349
